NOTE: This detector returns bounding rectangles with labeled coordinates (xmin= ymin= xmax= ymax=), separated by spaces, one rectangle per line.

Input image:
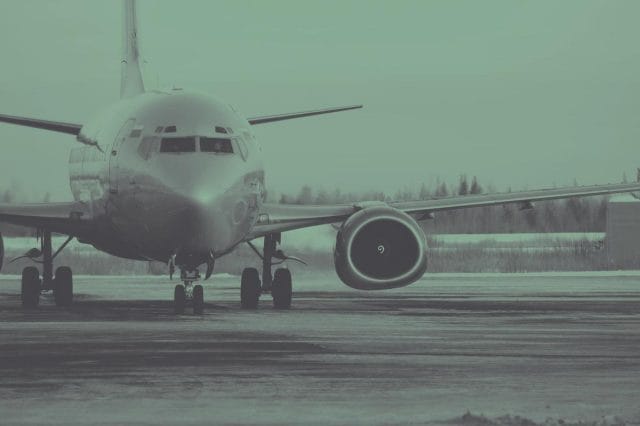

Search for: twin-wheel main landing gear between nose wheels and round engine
xmin=240 ymin=234 xmax=306 ymax=309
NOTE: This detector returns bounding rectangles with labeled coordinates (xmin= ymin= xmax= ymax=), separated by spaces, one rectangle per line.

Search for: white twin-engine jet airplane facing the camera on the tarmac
xmin=0 ymin=0 xmax=640 ymax=314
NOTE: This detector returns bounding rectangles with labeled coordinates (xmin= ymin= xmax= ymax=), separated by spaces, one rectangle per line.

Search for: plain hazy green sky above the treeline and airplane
xmin=0 ymin=0 xmax=640 ymax=200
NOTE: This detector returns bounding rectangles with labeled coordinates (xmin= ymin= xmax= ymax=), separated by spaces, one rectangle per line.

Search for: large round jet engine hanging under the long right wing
xmin=334 ymin=205 xmax=427 ymax=290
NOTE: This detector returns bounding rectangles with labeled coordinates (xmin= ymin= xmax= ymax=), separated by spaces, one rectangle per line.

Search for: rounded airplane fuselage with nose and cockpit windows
xmin=69 ymin=89 xmax=265 ymax=267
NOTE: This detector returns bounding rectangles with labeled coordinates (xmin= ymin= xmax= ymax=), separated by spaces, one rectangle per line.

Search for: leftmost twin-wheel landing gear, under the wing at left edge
xmin=18 ymin=230 xmax=73 ymax=309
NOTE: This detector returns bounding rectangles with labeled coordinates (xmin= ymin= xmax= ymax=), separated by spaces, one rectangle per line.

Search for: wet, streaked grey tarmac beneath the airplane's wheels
xmin=0 ymin=272 xmax=640 ymax=425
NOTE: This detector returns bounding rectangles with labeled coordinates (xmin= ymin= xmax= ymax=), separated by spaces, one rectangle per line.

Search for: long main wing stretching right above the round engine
xmin=247 ymin=183 xmax=640 ymax=240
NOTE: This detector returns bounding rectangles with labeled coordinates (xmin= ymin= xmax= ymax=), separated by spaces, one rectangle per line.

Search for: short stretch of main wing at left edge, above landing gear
xmin=0 ymin=202 xmax=91 ymax=235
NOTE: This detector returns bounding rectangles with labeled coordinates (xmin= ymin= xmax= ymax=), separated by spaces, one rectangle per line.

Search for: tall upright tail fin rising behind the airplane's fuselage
xmin=120 ymin=0 xmax=144 ymax=98
